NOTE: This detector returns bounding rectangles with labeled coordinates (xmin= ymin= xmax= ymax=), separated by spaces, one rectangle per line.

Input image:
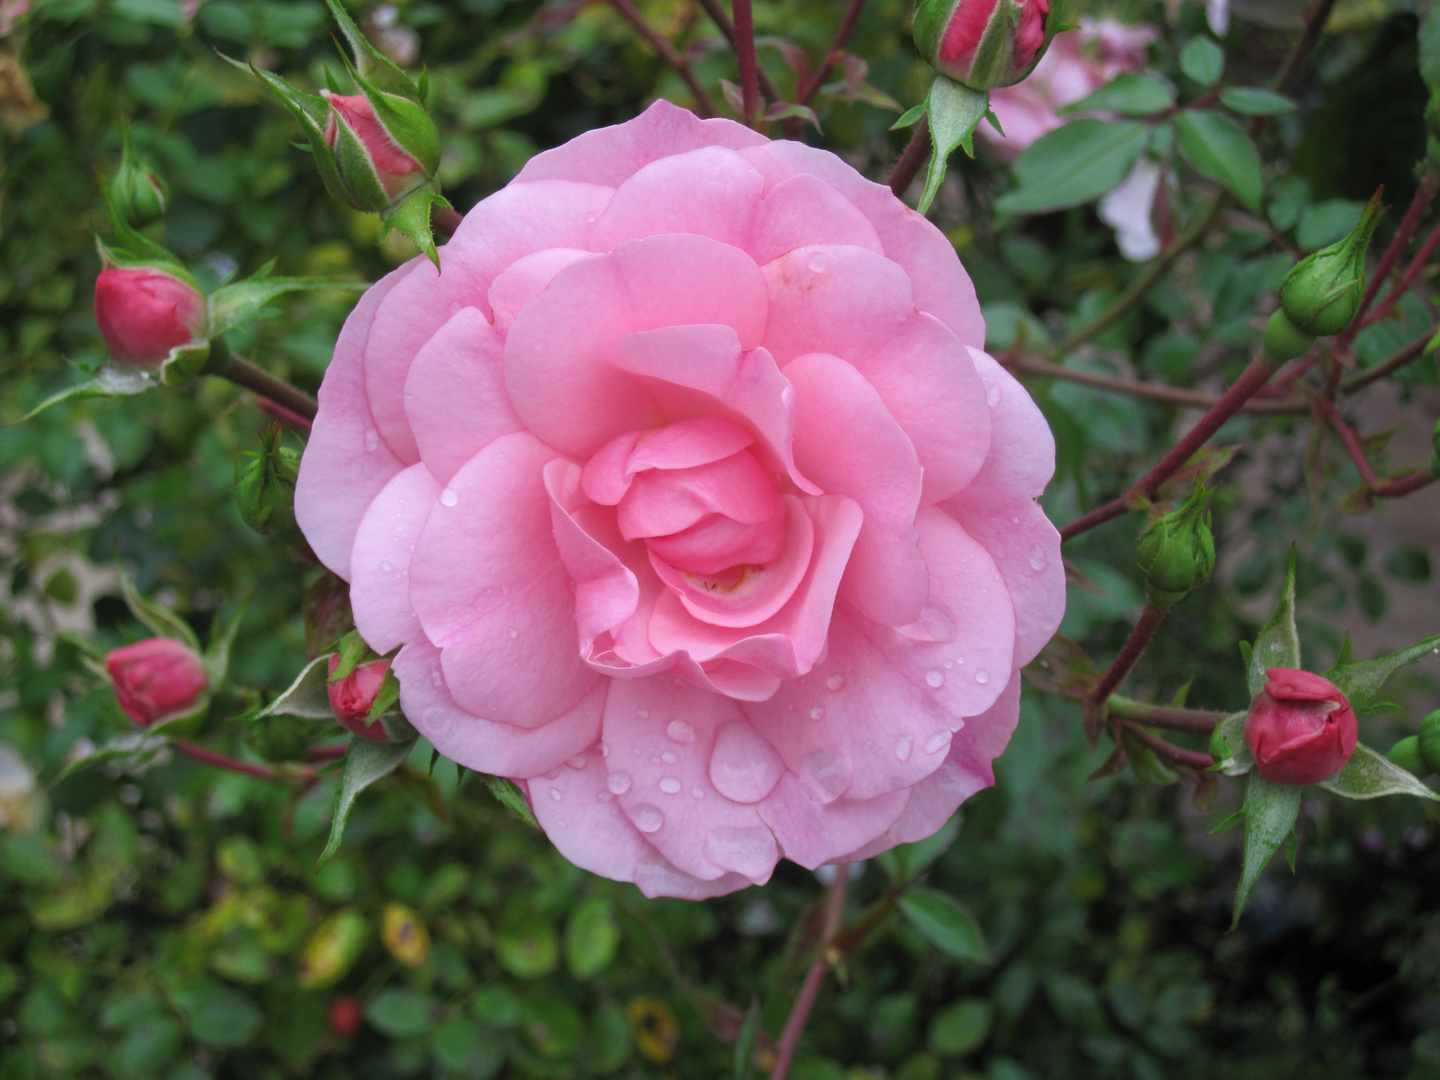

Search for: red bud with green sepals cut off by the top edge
xmin=914 ymin=0 xmax=1050 ymax=91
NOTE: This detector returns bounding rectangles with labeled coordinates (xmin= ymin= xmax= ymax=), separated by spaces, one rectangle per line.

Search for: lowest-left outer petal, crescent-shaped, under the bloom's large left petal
xmin=393 ymin=641 xmax=605 ymax=776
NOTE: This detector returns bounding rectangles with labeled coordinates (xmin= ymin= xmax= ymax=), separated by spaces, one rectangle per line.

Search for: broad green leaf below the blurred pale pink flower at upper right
xmin=996 ymin=120 xmax=1149 ymax=215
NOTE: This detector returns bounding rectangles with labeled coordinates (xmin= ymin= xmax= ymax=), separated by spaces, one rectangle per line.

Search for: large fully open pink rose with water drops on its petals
xmin=295 ymin=102 xmax=1064 ymax=897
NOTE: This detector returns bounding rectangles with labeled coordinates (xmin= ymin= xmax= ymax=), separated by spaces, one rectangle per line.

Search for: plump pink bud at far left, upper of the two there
xmin=95 ymin=266 xmax=204 ymax=367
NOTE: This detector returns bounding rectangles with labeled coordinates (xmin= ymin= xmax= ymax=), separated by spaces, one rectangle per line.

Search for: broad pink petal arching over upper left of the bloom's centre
xmin=505 ymin=235 xmax=766 ymax=458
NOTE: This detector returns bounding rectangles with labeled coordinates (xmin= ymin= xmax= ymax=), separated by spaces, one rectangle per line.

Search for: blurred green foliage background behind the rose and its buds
xmin=0 ymin=0 xmax=1440 ymax=1080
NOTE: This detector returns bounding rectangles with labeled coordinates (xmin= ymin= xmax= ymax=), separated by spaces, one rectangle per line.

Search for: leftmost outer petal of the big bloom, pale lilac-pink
xmin=295 ymin=256 xmax=423 ymax=580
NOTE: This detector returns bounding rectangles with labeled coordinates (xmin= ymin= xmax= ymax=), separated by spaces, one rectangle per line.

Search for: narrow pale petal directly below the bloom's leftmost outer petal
xmin=350 ymin=465 xmax=441 ymax=654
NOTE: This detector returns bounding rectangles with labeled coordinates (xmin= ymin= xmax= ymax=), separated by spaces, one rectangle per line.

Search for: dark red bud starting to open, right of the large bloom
xmin=1246 ymin=668 xmax=1358 ymax=785
